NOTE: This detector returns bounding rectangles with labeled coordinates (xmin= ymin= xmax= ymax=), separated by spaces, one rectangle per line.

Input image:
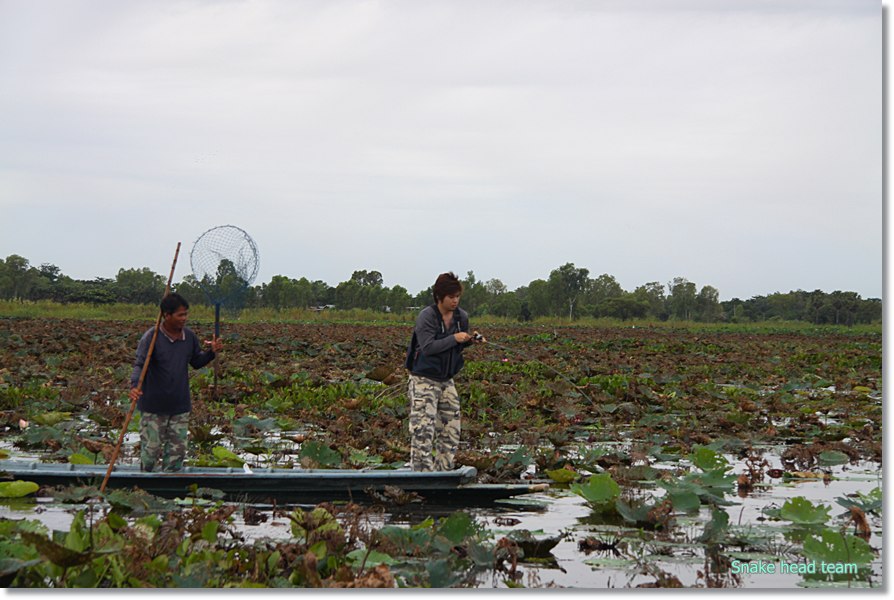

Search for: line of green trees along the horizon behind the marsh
xmin=0 ymin=254 xmax=882 ymax=325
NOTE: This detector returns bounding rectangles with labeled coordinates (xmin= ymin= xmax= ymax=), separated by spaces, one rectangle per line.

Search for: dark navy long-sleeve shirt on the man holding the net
xmin=130 ymin=327 xmax=214 ymax=415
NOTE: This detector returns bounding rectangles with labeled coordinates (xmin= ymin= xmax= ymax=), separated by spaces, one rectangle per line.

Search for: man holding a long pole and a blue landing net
xmin=130 ymin=294 xmax=223 ymax=471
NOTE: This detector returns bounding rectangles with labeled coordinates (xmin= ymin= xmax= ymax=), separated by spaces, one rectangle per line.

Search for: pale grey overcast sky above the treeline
xmin=0 ymin=0 xmax=883 ymax=300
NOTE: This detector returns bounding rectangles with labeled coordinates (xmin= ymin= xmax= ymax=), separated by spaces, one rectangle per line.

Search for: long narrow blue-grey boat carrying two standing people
xmin=0 ymin=460 xmax=544 ymax=504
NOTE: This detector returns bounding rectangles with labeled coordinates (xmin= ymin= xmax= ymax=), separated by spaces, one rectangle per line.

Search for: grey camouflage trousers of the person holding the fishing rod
xmin=407 ymin=375 xmax=460 ymax=471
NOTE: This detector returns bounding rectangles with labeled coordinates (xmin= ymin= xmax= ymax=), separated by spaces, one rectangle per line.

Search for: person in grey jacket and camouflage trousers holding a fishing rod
xmin=406 ymin=273 xmax=484 ymax=471
